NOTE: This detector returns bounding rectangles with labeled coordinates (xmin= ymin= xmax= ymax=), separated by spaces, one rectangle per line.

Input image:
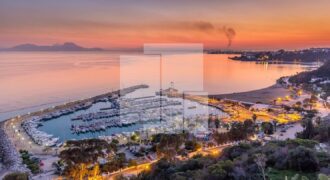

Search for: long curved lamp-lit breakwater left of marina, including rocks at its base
xmin=0 ymin=85 xmax=148 ymax=172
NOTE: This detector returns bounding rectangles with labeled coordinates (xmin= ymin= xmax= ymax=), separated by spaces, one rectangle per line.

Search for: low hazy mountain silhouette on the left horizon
xmin=1 ymin=42 xmax=103 ymax=51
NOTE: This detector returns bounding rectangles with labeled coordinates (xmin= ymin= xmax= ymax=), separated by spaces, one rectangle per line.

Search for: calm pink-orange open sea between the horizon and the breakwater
xmin=0 ymin=52 xmax=307 ymax=120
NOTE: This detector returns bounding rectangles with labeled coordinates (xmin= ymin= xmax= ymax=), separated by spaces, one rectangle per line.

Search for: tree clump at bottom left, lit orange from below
xmin=54 ymin=139 xmax=137 ymax=179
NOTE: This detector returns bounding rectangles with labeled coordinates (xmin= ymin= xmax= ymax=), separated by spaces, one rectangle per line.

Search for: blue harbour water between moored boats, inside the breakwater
xmin=38 ymin=96 xmax=227 ymax=142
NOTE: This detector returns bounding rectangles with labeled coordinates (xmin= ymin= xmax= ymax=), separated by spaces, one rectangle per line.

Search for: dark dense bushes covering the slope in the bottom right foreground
xmin=132 ymin=139 xmax=330 ymax=180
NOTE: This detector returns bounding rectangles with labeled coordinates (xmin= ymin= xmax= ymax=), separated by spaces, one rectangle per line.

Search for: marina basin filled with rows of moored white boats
xmin=13 ymin=86 xmax=227 ymax=147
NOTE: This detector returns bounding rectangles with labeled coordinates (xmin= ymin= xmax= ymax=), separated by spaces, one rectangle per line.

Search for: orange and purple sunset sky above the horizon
xmin=0 ymin=0 xmax=330 ymax=49
